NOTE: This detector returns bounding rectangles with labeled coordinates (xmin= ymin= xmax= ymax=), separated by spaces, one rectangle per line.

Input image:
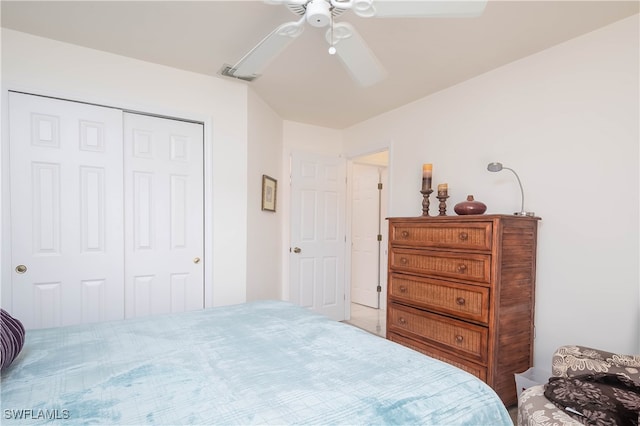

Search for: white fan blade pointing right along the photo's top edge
xmin=353 ymin=0 xmax=487 ymax=18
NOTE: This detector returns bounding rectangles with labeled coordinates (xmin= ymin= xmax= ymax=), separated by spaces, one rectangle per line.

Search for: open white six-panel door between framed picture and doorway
xmin=289 ymin=153 xmax=346 ymax=320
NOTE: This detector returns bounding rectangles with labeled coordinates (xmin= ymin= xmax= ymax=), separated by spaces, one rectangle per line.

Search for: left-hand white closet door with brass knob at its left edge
xmin=9 ymin=93 xmax=124 ymax=329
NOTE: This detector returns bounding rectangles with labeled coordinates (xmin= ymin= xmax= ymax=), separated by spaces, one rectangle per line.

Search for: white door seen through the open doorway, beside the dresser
xmin=351 ymin=163 xmax=382 ymax=309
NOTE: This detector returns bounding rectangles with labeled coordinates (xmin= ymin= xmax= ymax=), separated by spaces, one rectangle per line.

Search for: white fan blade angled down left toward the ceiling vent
xmin=230 ymin=17 xmax=304 ymax=78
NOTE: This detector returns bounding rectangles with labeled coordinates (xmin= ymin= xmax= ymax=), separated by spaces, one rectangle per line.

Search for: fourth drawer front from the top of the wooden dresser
xmin=387 ymin=304 xmax=488 ymax=363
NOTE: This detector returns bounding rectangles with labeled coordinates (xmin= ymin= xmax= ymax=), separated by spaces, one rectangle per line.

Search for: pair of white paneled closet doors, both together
xmin=9 ymin=92 xmax=204 ymax=329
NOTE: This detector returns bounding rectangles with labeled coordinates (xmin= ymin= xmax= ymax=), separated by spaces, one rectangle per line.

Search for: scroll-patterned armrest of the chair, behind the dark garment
xmin=551 ymin=345 xmax=640 ymax=383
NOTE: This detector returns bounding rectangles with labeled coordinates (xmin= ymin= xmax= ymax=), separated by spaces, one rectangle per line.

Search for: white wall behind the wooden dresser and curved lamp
xmin=344 ymin=15 xmax=640 ymax=370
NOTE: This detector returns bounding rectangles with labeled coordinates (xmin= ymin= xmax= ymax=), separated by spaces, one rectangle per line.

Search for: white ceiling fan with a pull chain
xmin=220 ymin=0 xmax=487 ymax=86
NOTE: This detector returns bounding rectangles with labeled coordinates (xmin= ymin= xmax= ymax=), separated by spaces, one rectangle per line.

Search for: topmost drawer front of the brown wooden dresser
xmin=389 ymin=222 xmax=492 ymax=251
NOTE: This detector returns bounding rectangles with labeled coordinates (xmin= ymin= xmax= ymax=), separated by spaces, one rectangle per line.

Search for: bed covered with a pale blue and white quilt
xmin=1 ymin=301 xmax=513 ymax=426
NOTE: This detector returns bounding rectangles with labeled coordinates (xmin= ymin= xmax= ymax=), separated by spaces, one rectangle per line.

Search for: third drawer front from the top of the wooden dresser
xmin=389 ymin=273 xmax=489 ymax=324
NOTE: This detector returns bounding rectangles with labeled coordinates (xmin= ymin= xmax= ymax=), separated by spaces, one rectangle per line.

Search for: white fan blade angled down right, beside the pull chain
xmin=327 ymin=22 xmax=387 ymax=86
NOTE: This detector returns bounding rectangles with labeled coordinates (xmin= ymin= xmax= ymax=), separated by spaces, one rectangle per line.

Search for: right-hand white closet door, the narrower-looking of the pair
xmin=124 ymin=113 xmax=204 ymax=318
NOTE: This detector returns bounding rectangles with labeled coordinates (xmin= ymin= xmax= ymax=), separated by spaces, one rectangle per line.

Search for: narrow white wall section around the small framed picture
xmin=247 ymin=90 xmax=288 ymax=300
